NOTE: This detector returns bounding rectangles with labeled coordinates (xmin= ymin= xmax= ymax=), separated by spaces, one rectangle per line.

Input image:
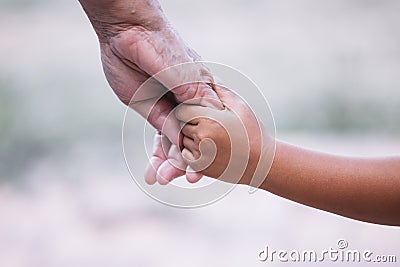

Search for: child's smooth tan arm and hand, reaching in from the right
xmin=176 ymin=87 xmax=400 ymax=226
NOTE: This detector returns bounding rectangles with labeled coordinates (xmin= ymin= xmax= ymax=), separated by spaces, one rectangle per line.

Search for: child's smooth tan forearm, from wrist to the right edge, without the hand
xmin=261 ymin=141 xmax=400 ymax=225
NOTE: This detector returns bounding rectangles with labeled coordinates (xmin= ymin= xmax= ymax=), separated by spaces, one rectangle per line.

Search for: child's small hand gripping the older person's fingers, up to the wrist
xmin=175 ymin=85 xmax=275 ymax=187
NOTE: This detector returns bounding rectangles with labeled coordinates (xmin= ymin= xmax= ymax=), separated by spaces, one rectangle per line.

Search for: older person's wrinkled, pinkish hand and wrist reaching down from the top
xmin=80 ymin=0 xmax=223 ymax=184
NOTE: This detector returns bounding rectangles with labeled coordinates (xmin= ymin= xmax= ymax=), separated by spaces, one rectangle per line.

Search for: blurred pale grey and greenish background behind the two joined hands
xmin=0 ymin=0 xmax=400 ymax=267
